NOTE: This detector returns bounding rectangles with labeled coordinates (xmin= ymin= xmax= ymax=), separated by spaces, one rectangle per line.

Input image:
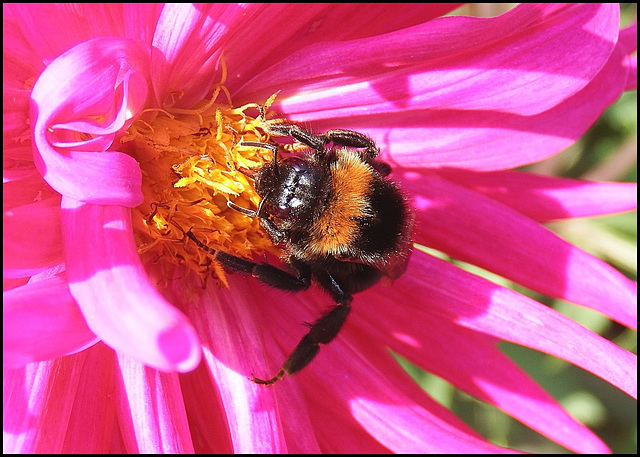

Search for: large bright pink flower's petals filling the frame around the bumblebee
xmin=3 ymin=4 xmax=637 ymax=453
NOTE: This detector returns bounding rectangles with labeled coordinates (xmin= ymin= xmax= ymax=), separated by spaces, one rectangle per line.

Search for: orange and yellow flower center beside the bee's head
xmin=122 ymin=84 xmax=280 ymax=285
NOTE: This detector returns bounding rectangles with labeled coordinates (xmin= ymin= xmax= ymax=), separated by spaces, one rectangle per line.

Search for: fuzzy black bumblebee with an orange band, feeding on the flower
xmin=186 ymin=121 xmax=413 ymax=385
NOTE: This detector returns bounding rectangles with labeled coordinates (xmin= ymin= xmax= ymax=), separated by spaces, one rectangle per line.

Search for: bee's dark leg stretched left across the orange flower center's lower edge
xmin=186 ymin=230 xmax=311 ymax=292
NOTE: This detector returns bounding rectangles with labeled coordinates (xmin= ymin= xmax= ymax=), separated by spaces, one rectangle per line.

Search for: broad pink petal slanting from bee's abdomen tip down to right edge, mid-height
xmin=402 ymin=174 xmax=637 ymax=328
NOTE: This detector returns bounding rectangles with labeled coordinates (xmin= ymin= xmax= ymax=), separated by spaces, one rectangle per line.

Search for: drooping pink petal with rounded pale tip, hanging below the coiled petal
xmin=62 ymin=197 xmax=200 ymax=371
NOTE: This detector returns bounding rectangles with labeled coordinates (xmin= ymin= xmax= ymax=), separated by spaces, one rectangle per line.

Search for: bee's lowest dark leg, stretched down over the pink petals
xmin=251 ymin=273 xmax=352 ymax=385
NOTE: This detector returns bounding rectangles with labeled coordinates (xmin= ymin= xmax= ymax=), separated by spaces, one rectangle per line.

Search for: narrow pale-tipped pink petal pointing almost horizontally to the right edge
xmin=422 ymin=168 xmax=638 ymax=222
